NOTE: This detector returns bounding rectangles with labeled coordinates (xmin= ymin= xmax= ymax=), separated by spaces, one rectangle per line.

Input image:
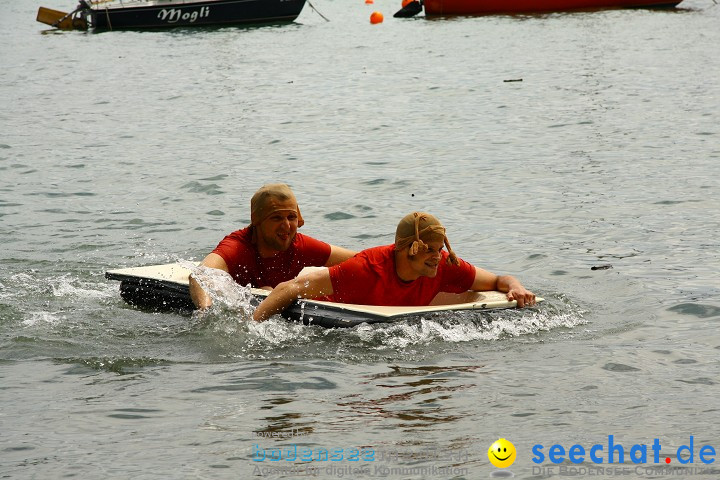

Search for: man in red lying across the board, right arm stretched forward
xmin=253 ymin=212 xmax=535 ymax=322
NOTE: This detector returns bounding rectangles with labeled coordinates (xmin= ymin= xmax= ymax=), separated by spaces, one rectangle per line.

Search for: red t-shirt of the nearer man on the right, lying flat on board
xmin=327 ymin=245 xmax=475 ymax=306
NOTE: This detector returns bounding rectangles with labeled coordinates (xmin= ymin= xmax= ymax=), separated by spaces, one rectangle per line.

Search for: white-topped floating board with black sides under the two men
xmin=105 ymin=263 xmax=542 ymax=327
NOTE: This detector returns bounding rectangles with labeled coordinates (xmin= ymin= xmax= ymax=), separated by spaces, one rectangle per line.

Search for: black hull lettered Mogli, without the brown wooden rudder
xmin=85 ymin=0 xmax=305 ymax=30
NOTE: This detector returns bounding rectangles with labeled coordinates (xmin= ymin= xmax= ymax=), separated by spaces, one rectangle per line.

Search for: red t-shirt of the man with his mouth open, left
xmin=213 ymin=227 xmax=330 ymax=288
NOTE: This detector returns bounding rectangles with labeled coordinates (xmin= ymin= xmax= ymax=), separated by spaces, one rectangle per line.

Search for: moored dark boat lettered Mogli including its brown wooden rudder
xmin=37 ymin=0 xmax=306 ymax=30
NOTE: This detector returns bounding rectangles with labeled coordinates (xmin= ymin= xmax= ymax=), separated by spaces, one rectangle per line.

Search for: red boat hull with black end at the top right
xmin=395 ymin=0 xmax=682 ymax=17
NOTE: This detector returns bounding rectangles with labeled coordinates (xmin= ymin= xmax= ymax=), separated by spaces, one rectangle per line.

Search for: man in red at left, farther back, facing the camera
xmin=190 ymin=184 xmax=355 ymax=308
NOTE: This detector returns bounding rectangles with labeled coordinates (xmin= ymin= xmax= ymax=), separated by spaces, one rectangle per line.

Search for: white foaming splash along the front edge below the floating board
xmin=205 ymin=299 xmax=587 ymax=361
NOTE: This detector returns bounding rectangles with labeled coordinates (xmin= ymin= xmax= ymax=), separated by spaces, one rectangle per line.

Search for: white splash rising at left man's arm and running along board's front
xmin=173 ymin=261 xmax=587 ymax=354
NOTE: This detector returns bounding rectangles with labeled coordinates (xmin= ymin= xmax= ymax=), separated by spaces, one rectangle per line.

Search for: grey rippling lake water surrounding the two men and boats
xmin=0 ymin=0 xmax=720 ymax=479
